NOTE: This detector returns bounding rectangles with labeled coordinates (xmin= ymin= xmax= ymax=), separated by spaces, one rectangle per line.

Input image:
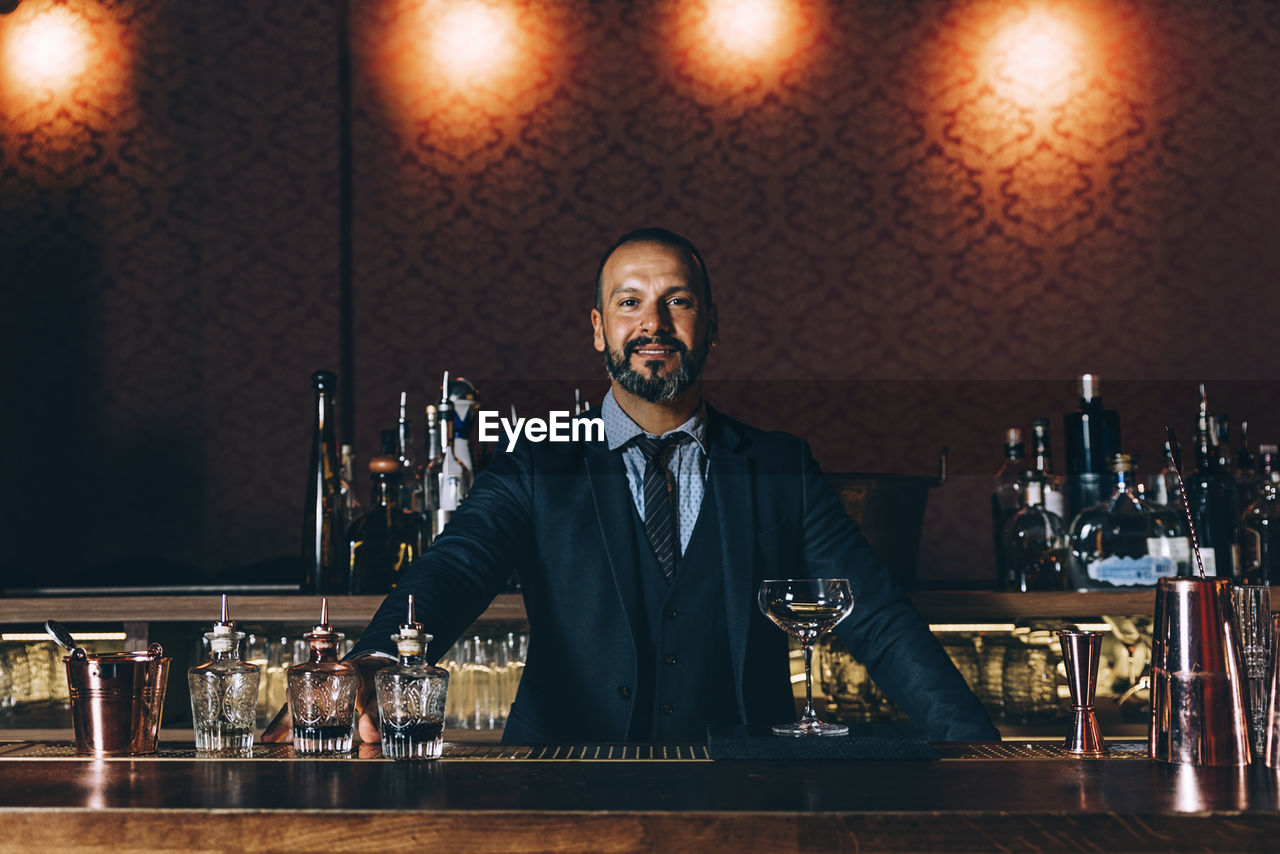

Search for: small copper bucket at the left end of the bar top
xmin=63 ymin=644 xmax=169 ymax=757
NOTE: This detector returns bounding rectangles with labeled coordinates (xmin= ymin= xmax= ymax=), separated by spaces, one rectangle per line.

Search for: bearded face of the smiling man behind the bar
xmin=591 ymin=243 xmax=716 ymax=403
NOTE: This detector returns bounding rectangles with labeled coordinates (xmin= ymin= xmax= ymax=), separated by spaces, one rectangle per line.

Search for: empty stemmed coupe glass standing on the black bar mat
xmin=756 ymin=579 xmax=854 ymax=736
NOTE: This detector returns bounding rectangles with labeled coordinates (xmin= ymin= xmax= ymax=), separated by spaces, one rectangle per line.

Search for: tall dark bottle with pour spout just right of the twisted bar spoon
xmin=1187 ymin=383 xmax=1240 ymax=577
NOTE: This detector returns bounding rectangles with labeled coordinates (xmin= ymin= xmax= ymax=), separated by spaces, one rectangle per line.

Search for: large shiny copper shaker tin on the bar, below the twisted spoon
xmin=1149 ymin=577 xmax=1251 ymax=766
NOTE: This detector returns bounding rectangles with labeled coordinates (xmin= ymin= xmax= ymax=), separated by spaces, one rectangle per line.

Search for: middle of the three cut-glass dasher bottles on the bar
xmin=288 ymin=599 xmax=360 ymax=755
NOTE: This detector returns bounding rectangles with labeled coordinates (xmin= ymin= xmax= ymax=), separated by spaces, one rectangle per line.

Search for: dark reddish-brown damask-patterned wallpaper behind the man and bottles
xmin=0 ymin=0 xmax=1280 ymax=580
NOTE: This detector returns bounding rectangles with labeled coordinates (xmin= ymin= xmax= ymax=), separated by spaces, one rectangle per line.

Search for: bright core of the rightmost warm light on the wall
xmin=993 ymin=10 xmax=1083 ymax=106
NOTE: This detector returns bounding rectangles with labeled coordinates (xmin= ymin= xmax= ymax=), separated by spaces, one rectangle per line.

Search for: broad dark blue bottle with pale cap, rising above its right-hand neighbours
xmin=1062 ymin=374 xmax=1120 ymax=519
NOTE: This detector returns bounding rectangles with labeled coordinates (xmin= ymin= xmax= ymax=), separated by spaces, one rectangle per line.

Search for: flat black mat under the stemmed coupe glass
xmin=707 ymin=723 xmax=937 ymax=759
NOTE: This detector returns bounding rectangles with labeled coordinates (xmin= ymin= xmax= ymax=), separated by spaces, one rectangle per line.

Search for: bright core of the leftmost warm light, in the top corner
xmin=5 ymin=8 xmax=90 ymax=91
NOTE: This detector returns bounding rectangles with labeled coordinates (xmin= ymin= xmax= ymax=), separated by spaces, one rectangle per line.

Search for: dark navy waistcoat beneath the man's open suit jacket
xmin=628 ymin=481 xmax=739 ymax=743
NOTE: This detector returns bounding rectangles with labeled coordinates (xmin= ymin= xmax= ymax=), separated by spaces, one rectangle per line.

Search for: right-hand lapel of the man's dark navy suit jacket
xmin=707 ymin=407 xmax=755 ymax=721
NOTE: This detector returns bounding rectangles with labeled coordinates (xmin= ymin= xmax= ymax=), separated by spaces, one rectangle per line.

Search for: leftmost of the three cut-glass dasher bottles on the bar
xmin=187 ymin=593 xmax=261 ymax=757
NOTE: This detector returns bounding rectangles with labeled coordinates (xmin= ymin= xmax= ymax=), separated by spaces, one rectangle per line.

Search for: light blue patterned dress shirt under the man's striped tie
xmin=600 ymin=389 xmax=707 ymax=554
